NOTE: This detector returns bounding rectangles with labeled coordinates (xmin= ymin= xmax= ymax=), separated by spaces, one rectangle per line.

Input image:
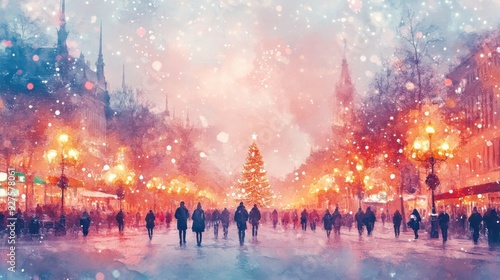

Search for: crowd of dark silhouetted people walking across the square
xmin=0 ymin=202 xmax=500 ymax=246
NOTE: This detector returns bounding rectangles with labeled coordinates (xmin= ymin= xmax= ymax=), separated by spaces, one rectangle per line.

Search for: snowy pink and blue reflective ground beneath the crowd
xmin=0 ymin=223 xmax=500 ymax=279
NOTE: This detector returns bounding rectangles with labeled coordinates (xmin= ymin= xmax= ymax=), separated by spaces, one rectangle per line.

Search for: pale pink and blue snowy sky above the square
xmin=4 ymin=0 xmax=500 ymax=177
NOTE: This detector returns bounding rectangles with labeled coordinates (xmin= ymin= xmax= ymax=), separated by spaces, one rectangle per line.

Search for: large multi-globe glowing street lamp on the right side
xmin=411 ymin=123 xmax=452 ymax=238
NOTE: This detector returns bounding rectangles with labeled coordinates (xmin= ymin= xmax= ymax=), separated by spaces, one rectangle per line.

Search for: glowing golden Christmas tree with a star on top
xmin=238 ymin=136 xmax=273 ymax=207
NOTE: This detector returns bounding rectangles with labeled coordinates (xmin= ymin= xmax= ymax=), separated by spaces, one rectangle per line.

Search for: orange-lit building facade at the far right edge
xmin=437 ymin=31 xmax=500 ymax=208
